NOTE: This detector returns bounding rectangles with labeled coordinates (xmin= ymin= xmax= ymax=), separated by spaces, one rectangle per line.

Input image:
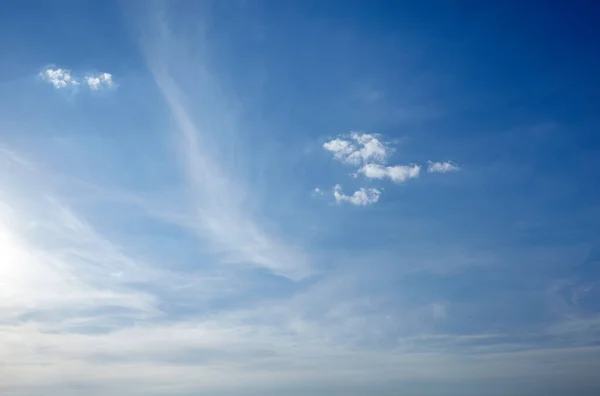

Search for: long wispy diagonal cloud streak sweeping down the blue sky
xmin=145 ymin=10 xmax=311 ymax=279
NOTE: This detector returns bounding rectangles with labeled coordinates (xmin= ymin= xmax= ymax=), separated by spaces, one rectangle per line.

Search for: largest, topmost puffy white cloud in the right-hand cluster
xmin=323 ymin=132 xmax=393 ymax=165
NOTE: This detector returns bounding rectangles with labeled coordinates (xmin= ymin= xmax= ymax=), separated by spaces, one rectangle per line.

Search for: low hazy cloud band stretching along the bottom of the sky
xmin=0 ymin=318 xmax=600 ymax=396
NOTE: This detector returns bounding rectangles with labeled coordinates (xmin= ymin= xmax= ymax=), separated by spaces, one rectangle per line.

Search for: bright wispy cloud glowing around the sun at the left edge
xmin=0 ymin=145 xmax=234 ymax=324
